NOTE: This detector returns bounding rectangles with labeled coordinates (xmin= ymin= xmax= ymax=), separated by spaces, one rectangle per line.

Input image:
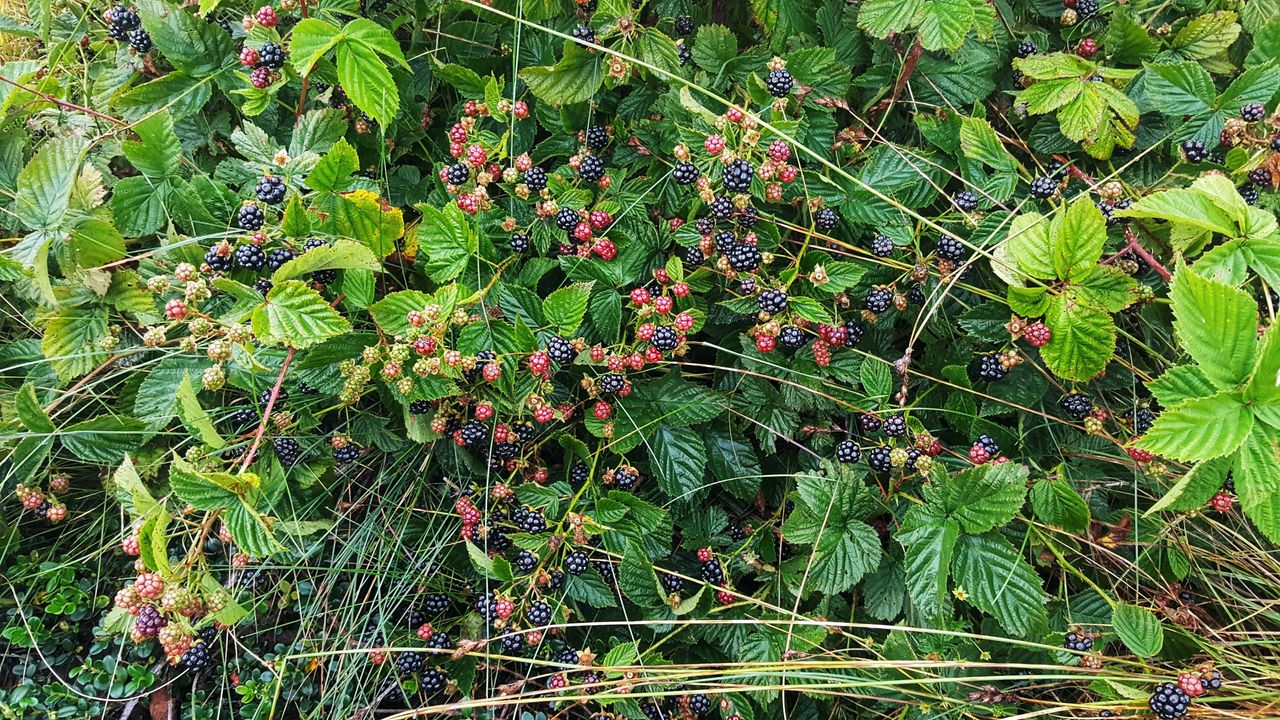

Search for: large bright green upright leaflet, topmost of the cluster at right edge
xmin=1169 ymin=266 xmax=1258 ymax=388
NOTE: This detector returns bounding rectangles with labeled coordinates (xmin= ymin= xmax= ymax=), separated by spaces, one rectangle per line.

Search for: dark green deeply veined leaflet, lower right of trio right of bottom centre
xmin=954 ymin=534 xmax=1048 ymax=638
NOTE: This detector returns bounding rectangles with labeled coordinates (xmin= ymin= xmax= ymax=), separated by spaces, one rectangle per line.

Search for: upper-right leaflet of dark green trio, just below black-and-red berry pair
xmin=942 ymin=462 xmax=1027 ymax=534
